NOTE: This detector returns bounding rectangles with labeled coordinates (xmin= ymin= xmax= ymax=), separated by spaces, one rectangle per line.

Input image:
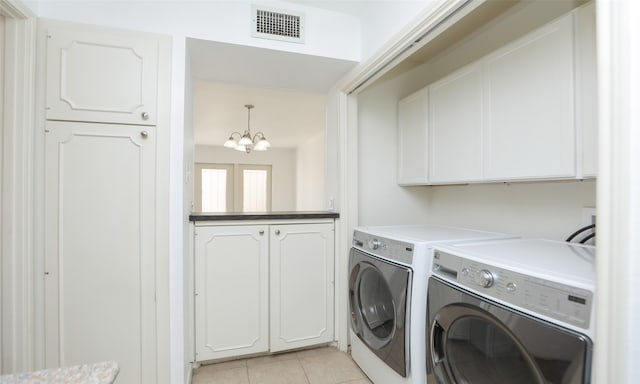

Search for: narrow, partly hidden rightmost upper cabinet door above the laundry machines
xmin=575 ymin=3 xmax=598 ymax=177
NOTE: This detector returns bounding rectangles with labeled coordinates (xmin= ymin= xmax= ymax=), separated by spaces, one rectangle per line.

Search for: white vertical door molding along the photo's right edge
xmin=591 ymin=0 xmax=640 ymax=383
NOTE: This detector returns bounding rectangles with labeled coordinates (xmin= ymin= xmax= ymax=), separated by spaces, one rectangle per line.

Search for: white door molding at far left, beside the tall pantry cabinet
xmin=0 ymin=0 xmax=39 ymax=373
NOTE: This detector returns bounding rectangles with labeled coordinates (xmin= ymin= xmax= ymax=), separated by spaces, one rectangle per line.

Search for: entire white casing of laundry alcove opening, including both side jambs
xmin=335 ymin=0 xmax=640 ymax=383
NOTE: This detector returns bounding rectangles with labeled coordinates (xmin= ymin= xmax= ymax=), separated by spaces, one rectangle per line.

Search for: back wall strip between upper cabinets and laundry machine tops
xmin=425 ymin=180 xmax=596 ymax=240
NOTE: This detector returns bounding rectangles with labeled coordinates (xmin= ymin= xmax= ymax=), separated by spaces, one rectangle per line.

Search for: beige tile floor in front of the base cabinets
xmin=192 ymin=347 xmax=372 ymax=384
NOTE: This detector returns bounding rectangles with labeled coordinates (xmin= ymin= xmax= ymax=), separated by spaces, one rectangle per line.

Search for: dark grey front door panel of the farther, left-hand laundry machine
xmin=349 ymin=249 xmax=411 ymax=377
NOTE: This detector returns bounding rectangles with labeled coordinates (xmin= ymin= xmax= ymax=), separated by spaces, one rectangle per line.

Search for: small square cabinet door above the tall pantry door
xmin=46 ymin=27 xmax=158 ymax=125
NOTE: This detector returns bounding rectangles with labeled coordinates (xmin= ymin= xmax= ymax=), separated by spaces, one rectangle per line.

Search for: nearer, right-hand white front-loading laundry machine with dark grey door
xmin=426 ymin=239 xmax=596 ymax=384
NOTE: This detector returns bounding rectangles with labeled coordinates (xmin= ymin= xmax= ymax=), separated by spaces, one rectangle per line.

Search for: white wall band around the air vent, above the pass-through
xmin=26 ymin=0 xmax=360 ymax=61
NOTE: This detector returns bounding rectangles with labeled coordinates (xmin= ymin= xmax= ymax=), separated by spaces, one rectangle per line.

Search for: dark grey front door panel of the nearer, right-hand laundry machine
xmin=428 ymin=277 xmax=591 ymax=384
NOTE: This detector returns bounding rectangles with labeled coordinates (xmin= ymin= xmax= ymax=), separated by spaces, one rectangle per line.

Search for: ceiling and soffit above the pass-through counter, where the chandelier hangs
xmin=187 ymin=39 xmax=358 ymax=148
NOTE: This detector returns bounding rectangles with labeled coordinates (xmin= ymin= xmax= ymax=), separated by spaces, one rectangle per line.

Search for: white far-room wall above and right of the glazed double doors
xmin=196 ymin=145 xmax=296 ymax=211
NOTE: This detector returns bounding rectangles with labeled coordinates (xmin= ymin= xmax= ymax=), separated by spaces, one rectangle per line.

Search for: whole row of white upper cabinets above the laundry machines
xmin=398 ymin=3 xmax=597 ymax=185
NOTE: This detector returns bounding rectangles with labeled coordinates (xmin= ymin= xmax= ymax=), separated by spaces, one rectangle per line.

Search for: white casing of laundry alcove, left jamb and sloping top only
xmin=332 ymin=0 xmax=486 ymax=351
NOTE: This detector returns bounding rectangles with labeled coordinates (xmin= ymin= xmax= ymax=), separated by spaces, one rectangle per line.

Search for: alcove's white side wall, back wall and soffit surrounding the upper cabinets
xmin=358 ymin=3 xmax=595 ymax=239
